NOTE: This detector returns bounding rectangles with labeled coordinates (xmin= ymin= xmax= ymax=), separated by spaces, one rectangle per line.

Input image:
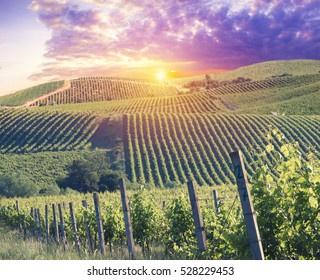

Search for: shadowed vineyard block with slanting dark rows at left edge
xmin=0 ymin=109 xmax=100 ymax=153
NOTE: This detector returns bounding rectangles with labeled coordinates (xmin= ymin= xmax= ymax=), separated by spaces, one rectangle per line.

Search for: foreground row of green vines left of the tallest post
xmin=0 ymin=184 xmax=250 ymax=259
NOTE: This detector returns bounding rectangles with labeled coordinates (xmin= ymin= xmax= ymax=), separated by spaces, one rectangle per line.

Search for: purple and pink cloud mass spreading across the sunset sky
xmin=30 ymin=0 xmax=320 ymax=79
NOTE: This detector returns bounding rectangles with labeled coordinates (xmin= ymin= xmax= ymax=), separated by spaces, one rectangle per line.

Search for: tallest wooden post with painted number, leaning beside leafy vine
xmin=230 ymin=150 xmax=264 ymax=260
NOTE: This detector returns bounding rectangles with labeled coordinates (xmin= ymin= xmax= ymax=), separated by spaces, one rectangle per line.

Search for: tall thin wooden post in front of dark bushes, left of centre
xmin=119 ymin=179 xmax=135 ymax=259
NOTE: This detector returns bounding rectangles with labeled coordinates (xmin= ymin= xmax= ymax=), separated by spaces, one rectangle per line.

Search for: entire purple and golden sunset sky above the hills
xmin=0 ymin=0 xmax=320 ymax=95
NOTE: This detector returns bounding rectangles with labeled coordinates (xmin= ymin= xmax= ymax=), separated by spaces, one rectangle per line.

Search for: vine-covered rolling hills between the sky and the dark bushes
xmin=0 ymin=61 xmax=320 ymax=189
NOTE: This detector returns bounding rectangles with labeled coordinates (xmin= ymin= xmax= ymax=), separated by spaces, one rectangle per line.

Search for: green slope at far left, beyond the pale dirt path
xmin=0 ymin=81 xmax=64 ymax=106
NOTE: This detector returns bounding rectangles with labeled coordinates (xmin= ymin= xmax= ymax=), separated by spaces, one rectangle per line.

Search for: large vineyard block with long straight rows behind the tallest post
xmin=123 ymin=113 xmax=320 ymax=186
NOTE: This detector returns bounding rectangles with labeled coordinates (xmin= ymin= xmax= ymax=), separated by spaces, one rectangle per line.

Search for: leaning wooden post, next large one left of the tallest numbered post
xmin=188 ymin=181 xmax=207 ymax=253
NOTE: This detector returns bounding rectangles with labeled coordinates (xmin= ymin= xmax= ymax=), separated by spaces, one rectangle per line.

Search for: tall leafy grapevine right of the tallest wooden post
xmin=252 ymin=130 xmax=320 ymax=259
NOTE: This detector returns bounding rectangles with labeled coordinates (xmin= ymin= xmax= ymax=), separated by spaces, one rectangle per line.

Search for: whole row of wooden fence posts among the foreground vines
xmin=2 ymin=151 xmax=264 ymax=260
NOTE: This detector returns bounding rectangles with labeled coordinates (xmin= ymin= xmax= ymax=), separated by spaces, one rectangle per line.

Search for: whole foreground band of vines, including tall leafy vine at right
xmin=0 ymin=142 xmax=320 ymax=259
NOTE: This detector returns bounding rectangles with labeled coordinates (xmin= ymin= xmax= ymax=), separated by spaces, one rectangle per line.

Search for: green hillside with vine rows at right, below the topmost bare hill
xmin=206 ymin=74 xmax=320 ymax=115
